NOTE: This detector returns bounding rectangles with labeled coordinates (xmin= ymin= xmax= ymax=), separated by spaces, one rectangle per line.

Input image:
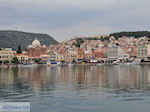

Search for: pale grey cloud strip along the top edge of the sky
xmin=1 ymin=0 xmax=117 ymax=10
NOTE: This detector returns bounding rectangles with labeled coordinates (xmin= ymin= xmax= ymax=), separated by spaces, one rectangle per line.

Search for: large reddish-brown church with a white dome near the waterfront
xmin=27 ymin=38 xmax=47 ymax=59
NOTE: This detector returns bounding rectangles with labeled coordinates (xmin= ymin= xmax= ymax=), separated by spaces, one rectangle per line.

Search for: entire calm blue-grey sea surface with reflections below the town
xmin=0 ymin=65 xmax=150 ymax=112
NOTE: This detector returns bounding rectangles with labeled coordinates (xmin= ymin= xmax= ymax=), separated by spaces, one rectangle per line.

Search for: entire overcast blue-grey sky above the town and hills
xmin=0 ymin=0 xmax=150 ymax=41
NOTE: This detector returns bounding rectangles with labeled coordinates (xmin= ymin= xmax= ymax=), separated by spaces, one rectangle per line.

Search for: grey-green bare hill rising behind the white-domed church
xmin=0 ymin=30 xmax=58 ymax=50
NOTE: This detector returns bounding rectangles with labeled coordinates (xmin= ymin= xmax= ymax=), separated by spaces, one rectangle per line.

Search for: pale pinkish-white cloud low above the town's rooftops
xmin=49 ymin=21 xmax=116 ymax=41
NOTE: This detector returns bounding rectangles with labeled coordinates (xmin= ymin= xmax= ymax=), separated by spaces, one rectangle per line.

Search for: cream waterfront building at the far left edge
xmin=0 ymin=48 xmax=16 ymax=62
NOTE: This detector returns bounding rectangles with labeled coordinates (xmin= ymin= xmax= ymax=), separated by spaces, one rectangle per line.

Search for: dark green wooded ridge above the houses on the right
xmin=110 ymin=31 xmax=150 ymax=39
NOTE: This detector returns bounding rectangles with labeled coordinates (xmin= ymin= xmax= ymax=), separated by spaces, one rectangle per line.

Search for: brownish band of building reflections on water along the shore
xmin=0 ymin=66 xmax=150 ymax=93
